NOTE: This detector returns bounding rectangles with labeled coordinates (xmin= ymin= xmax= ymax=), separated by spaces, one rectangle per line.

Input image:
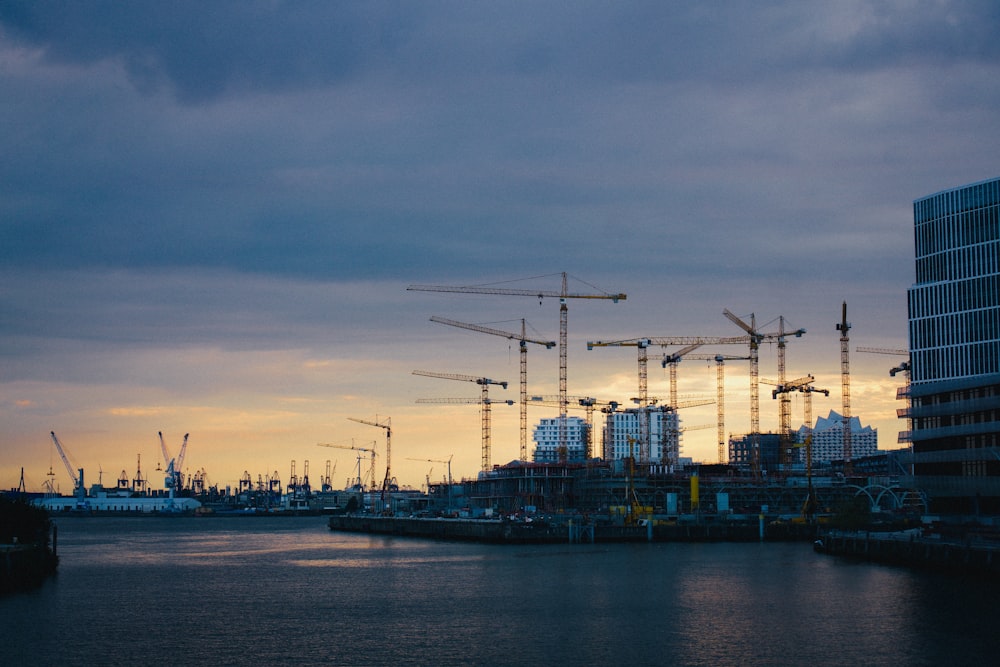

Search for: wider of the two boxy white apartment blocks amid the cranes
xmin=604 ymin=407 xmax=680 ymax=465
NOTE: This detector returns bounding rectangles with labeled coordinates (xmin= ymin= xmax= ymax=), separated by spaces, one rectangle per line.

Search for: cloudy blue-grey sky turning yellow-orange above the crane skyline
xmin=0 ymin=0 xmax=1000 ymax=493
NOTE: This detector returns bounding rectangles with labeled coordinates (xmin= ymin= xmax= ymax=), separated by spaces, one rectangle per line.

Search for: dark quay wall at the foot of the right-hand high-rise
xmin=816 ymin=532 xmax=1000 ymax=580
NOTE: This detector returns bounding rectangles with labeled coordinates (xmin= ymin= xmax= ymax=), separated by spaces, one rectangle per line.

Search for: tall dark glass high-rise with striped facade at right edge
xmin=908 ymin=178 xmax=1000 ymax=514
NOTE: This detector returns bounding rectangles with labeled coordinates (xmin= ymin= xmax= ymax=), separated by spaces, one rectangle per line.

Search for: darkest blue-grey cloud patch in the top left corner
xmin=0 ymin=0 xmax=412 ymax=103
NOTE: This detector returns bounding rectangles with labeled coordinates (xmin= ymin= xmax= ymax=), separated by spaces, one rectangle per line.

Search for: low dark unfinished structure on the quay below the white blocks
xmin=428 ymin=452 xmax=925 ymax=518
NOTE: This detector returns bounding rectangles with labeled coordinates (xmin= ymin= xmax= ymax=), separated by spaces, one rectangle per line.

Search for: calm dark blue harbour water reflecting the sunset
xmin=0 ymin=517 xmax=1000 ymax=665
